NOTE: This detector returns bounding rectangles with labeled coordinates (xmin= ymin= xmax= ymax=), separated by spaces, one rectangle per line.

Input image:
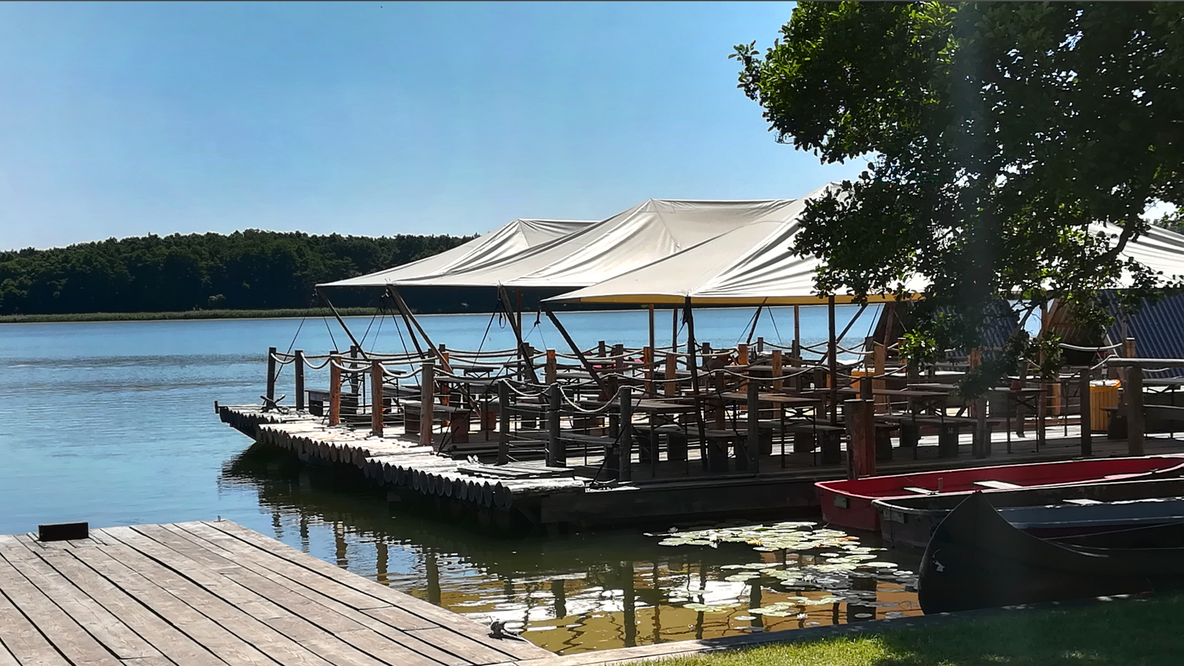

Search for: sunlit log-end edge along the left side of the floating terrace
xmin=218 ymin=398 xmax=586 ymax=510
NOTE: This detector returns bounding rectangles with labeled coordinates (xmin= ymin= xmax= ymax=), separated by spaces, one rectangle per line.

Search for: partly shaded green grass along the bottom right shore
xmin=644 ymin=596 xmax=1184 ymax=666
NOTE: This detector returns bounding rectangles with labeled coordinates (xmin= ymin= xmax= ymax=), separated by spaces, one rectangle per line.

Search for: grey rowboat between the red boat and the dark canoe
xmin=871 ymin=478 xmax=1184 ymax=549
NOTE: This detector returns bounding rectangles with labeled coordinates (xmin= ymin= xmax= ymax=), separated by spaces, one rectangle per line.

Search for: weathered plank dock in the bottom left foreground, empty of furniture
xmin=0 ymin=520 xmax=551 ymax=666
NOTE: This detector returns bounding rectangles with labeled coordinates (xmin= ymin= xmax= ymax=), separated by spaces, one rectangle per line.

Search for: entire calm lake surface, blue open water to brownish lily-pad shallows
xmin=0 ymin=308 xmax=919 ymax=653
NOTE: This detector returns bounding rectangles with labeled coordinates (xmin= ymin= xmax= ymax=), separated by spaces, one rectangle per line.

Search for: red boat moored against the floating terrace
xmin=815 ymin=455 xmax=1184 ymax=532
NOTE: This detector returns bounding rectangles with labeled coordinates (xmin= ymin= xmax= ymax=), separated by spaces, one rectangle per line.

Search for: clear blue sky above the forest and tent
xmin=0 ymin=2 xmax=861 ymax=249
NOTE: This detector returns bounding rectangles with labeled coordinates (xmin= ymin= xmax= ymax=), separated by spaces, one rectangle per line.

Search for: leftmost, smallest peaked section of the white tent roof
xmin=318 ymin=219 xmax=596 ymax=287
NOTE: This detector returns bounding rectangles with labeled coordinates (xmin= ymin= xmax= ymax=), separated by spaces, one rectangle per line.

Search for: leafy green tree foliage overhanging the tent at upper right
xmin=733 ymin=2 xmax=1184 ymax=384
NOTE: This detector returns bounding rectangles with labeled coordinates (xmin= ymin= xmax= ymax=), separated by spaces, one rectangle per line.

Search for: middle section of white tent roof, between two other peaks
xmin=378 ymin=193 xmax=814 ymax=289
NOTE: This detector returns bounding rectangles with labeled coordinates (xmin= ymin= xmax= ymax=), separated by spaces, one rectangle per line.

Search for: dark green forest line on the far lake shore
xmin=0 ymin=230 xmax=471 ymax=314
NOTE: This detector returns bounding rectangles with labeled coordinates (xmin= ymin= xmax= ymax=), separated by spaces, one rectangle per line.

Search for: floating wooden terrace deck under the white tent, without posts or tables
xmin=218 ymin=398 xmax=1184 ymax=533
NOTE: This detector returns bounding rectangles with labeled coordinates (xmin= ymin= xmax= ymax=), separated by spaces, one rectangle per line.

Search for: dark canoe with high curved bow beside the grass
xmin=916 ymin=493 xmax=1184 ymax=614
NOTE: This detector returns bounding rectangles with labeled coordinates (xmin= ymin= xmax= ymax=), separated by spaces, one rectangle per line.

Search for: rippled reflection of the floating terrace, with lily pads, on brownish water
xmin=221 ymin=446 xmax=920 ymax=654
